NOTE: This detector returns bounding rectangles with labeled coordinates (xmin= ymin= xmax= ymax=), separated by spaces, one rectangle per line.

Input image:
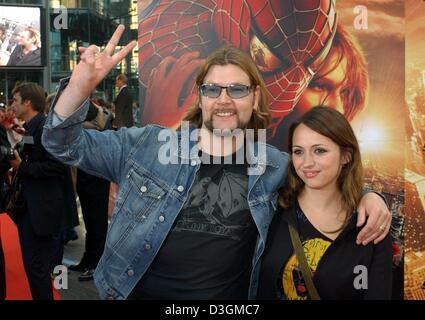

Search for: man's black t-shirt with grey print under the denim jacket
xmin=129 ymin=152 xmax=257 ymax=299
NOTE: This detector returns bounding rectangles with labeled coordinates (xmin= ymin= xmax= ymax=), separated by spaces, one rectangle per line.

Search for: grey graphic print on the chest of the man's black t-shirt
xmin=173 ymin=169 xmax=251 ymax=240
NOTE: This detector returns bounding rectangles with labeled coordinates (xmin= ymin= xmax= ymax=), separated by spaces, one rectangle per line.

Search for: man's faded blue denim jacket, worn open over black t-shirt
xmin=42 ymin=77 xmax=288 ymax=300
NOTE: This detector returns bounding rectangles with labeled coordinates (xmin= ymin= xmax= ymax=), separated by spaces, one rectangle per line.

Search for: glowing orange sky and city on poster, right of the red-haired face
xmin=337 ymin=0 xmax=406 ymax=299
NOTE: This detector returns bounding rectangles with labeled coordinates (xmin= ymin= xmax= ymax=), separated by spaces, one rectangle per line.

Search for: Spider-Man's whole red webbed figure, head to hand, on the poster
xmin=139 ymin=0 xmax=336 ymax=137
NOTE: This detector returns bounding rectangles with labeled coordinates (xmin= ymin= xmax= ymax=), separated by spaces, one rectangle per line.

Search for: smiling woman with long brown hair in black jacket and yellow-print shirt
xmin=258 ymin=107 xmax=392 ymax=300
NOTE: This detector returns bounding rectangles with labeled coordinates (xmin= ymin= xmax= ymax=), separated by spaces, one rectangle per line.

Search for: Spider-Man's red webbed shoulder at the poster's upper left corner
xmin=138 ymin=0 xmax=218 ymax=88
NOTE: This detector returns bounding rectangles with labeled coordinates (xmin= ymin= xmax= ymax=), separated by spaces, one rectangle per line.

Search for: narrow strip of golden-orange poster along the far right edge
xmin=404 ymin=0 xmax=425 ymax=300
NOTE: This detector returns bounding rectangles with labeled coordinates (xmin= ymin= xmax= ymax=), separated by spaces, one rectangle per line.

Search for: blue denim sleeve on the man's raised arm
xmin=42 ymin=77 xmax=147 ymax=183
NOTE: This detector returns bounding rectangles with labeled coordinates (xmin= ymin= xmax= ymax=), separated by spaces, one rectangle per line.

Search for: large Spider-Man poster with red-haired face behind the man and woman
xmin=138 ymin=0 xmax=404 ymax=298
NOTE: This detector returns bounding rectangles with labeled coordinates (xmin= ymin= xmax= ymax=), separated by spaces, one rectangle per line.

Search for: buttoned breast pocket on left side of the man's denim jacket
xmin=122 ymin=171 xmax=166 ymax=222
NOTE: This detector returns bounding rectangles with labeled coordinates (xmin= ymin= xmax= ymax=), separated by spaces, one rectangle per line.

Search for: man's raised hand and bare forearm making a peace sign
xmin=55 ymin=25 xmax=136 ymax=117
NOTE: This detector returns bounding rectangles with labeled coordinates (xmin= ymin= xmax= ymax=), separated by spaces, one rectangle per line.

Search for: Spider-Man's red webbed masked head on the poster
xmin=214 ymin=0 xmax=336 ymax=128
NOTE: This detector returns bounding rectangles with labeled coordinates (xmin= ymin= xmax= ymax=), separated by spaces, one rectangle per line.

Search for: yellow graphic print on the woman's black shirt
xmin=282 ymin=238 xmax=331 ymax=300
